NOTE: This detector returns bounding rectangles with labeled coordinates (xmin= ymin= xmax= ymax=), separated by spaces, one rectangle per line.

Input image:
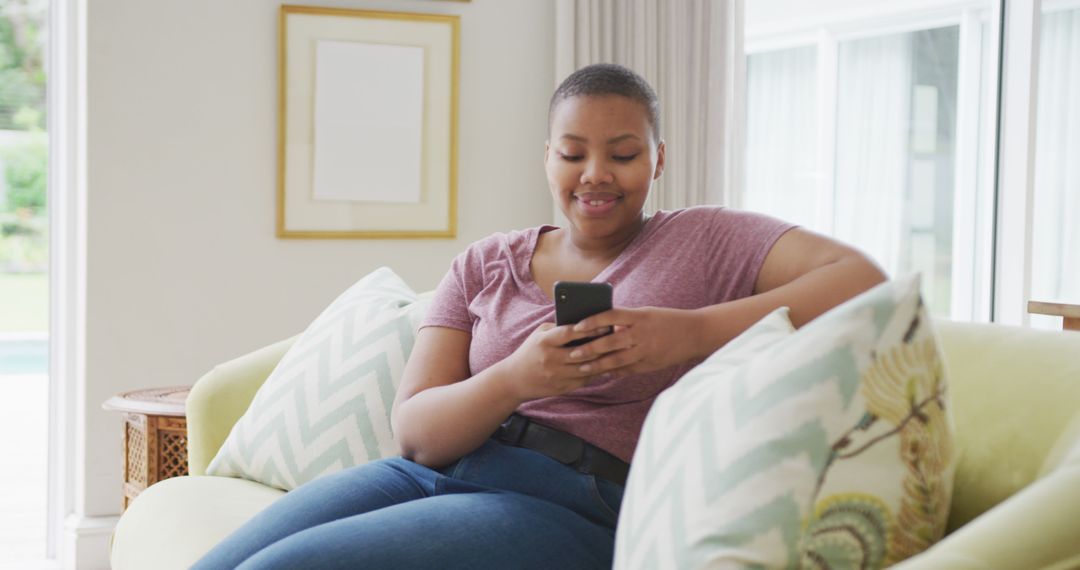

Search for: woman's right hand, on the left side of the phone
xmin=500 ymin=323 xmax=607 ymax=403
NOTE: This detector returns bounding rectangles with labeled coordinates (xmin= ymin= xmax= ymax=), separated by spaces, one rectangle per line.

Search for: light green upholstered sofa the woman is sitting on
xmin=111 ymin=322 xmax=1080 ymax=570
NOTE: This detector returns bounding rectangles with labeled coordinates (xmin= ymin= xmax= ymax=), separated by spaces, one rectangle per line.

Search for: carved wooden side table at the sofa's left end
xmin=102 ymin=386 xmax=191 ymax=510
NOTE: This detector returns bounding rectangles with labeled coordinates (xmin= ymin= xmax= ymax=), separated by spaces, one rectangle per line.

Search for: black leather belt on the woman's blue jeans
xmin=494 ymin=413 xmax=630 ymax=485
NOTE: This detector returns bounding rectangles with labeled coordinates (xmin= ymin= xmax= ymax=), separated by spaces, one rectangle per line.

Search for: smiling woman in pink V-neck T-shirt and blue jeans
xmin=197 ymin=65 xmax=885 ymax=569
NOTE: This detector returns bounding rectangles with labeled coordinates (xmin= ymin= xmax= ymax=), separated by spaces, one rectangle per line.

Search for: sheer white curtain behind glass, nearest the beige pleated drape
xmin=742 ymin=46 xmax=827 ymax=231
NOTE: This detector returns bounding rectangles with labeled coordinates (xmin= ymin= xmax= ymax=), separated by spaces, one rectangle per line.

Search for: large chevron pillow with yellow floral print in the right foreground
xmin=615 ymin=275 xmax=955 ymax=569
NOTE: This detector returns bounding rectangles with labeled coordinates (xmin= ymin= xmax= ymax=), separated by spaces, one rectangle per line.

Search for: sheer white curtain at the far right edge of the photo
xmin=1031 ymin=5 xmax=1080 ymax=306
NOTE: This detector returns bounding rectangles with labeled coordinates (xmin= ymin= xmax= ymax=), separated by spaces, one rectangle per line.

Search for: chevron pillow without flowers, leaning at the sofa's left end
xmin=206 ymin=268 xmax=429 ymax=490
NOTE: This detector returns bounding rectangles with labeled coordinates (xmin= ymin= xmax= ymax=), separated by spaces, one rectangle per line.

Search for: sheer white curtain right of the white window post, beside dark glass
xmin=834 ymin=33 xmax=913 ymax=271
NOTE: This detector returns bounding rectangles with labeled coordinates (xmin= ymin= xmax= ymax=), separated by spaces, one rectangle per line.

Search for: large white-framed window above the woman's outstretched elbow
xmin=742 ymin=0 xmax=996 ymax=320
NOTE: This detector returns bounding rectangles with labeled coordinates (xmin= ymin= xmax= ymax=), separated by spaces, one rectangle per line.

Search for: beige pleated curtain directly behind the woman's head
xmin=555 ymin=0 xmax=743 ymax=213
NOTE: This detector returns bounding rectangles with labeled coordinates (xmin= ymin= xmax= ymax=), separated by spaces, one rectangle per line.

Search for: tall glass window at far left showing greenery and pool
xmin=0 ymin=0 xmax=50 ymax=568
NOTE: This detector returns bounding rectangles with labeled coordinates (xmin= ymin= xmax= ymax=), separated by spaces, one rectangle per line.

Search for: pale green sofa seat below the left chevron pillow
xmin=111 ymin=477 xmax=284 ymax=570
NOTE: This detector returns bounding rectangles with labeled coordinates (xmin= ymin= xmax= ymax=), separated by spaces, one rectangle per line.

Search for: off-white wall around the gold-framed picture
xmin=77 ymin=0 xmax=554 ymax=561
